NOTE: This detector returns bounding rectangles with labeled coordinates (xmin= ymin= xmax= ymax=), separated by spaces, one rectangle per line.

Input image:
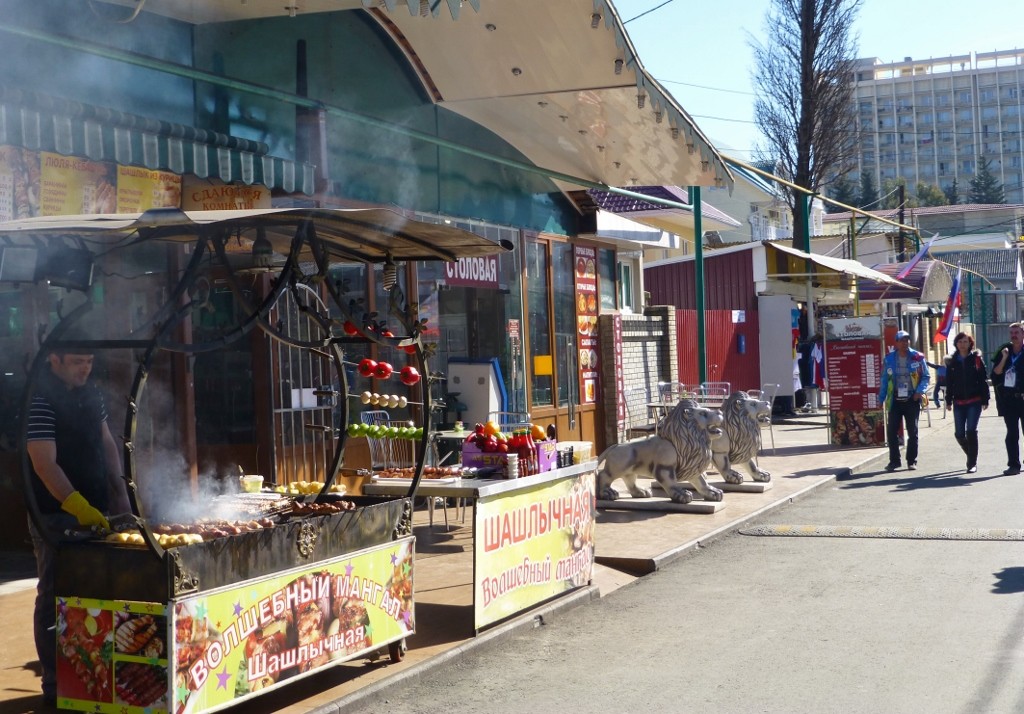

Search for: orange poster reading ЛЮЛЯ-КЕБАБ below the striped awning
xmin=39 ymin=152 xmax=118 ymax=216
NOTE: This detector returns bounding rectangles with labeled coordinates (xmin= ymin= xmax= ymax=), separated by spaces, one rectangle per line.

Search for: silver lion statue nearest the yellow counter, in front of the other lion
xmin=597 ymin=400 xmax=722 ymax=503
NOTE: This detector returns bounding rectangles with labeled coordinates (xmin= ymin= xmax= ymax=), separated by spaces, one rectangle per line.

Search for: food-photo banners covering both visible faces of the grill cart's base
xmin=57 ymin=538 xmax=416 ymax=714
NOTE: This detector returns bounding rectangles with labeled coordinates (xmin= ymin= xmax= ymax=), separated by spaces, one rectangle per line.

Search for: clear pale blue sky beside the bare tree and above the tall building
xmin=612 ymin=0 xmax=1024 ymax=161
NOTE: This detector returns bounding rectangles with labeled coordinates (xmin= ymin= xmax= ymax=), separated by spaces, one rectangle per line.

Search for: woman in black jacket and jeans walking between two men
xmin=945 ymin=332 xmax=989 ymax=473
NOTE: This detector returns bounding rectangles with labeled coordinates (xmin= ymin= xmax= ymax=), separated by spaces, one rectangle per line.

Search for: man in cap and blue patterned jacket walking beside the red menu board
xmin=879 ymin=330 xmax=929 ymax=471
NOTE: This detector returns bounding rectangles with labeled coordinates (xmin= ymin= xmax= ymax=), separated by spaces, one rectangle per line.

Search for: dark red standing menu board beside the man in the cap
xmin=824 ymin=318 xmax=886 ymax=447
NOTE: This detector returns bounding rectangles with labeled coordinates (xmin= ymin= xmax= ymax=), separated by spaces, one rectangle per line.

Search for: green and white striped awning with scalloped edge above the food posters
xmin=0 ymin=85 xmax=314 ymax=196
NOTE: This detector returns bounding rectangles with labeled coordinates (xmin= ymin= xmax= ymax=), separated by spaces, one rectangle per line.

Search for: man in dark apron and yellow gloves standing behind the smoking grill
xmin=26 ymin=336 xmax=130 ymax=704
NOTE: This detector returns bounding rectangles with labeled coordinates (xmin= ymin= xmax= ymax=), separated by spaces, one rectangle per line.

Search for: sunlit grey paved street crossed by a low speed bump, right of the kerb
xmin=362 ymin=409 xmax=1024 ymax=714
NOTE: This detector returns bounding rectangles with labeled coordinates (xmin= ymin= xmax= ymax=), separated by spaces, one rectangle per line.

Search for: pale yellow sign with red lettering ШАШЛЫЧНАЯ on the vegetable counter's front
xmin=473 ymin=471 xmax=597 ymax=629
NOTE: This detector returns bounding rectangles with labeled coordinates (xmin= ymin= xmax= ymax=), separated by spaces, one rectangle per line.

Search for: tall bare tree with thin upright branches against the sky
xmin=751 ymin=0 xmax=861 ymax=248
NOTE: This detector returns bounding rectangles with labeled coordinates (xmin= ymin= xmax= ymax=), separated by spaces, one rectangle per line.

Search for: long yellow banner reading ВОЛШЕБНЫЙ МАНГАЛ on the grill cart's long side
xmin=174 ymin=538 xmax=415 ymax=714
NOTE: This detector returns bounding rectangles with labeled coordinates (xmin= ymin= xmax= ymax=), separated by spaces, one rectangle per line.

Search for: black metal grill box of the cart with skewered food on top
xmin=57 ymin=494 xmax=412 ymax=602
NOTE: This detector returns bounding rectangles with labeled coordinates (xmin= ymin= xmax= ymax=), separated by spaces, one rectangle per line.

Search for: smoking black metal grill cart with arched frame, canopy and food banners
xmin=9 ymin=209 xmax=511 ymax=714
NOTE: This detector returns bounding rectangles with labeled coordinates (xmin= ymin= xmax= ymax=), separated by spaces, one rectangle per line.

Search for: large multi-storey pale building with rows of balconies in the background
xmin=851 ymin=49 xmax=1024 ymax=203
